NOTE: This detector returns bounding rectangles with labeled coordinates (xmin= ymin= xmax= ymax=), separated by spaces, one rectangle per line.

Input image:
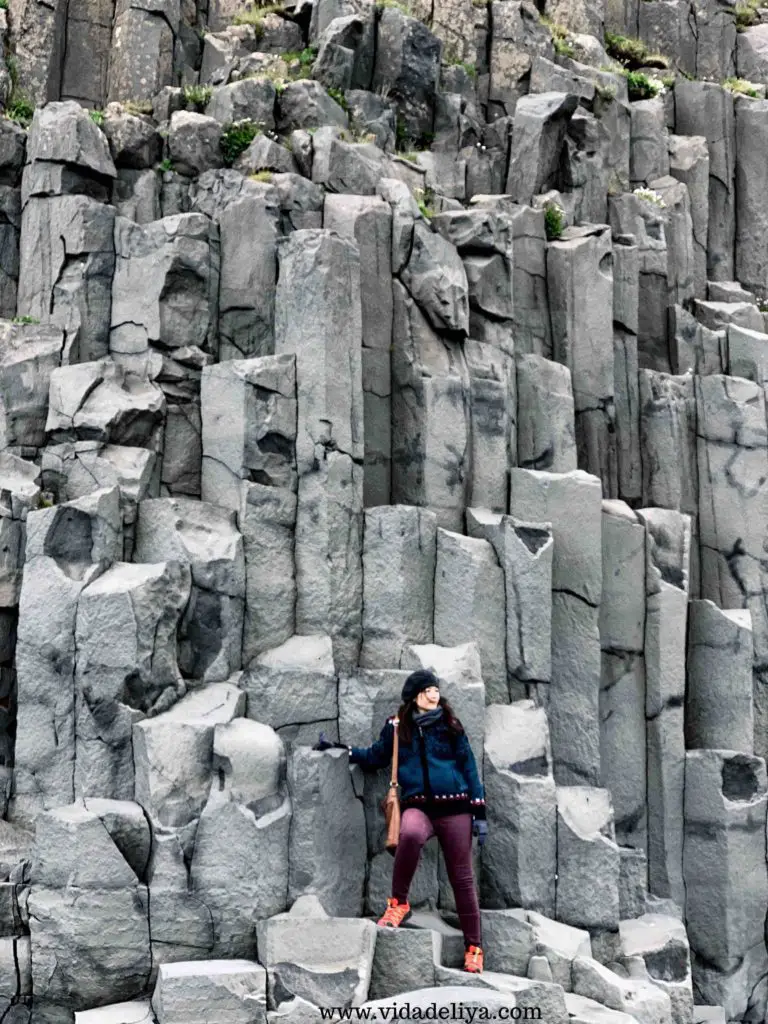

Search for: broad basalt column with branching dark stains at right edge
xmin=694 ymin=375 xmax=768 ymax=757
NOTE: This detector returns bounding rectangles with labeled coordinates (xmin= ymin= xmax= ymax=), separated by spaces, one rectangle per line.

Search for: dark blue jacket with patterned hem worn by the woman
xmin=349 ymin=718 xmax=485 ymax=820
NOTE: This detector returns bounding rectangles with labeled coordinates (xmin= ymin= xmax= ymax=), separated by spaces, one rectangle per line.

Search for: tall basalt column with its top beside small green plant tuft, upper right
xmin=547 ymin=226 xmax=618 ymax=498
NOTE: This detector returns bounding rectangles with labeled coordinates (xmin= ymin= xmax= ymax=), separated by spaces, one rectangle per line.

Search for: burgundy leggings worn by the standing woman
xmin=392 ymin=807 xmax=481 ymax=946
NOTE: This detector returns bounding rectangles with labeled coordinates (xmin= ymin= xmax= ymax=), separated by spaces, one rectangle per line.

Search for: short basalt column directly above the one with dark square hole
xmin=685 ymin=601 xmax=755 ymax=754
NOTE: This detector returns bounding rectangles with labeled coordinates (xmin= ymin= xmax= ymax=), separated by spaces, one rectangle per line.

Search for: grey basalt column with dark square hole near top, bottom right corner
xmin=683 ymin=751 xmax=768 ymax=1020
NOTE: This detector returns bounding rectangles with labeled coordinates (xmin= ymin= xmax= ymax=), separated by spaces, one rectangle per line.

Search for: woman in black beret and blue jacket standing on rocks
xmin=314 ymin=669 xmax=487 ymax=974
